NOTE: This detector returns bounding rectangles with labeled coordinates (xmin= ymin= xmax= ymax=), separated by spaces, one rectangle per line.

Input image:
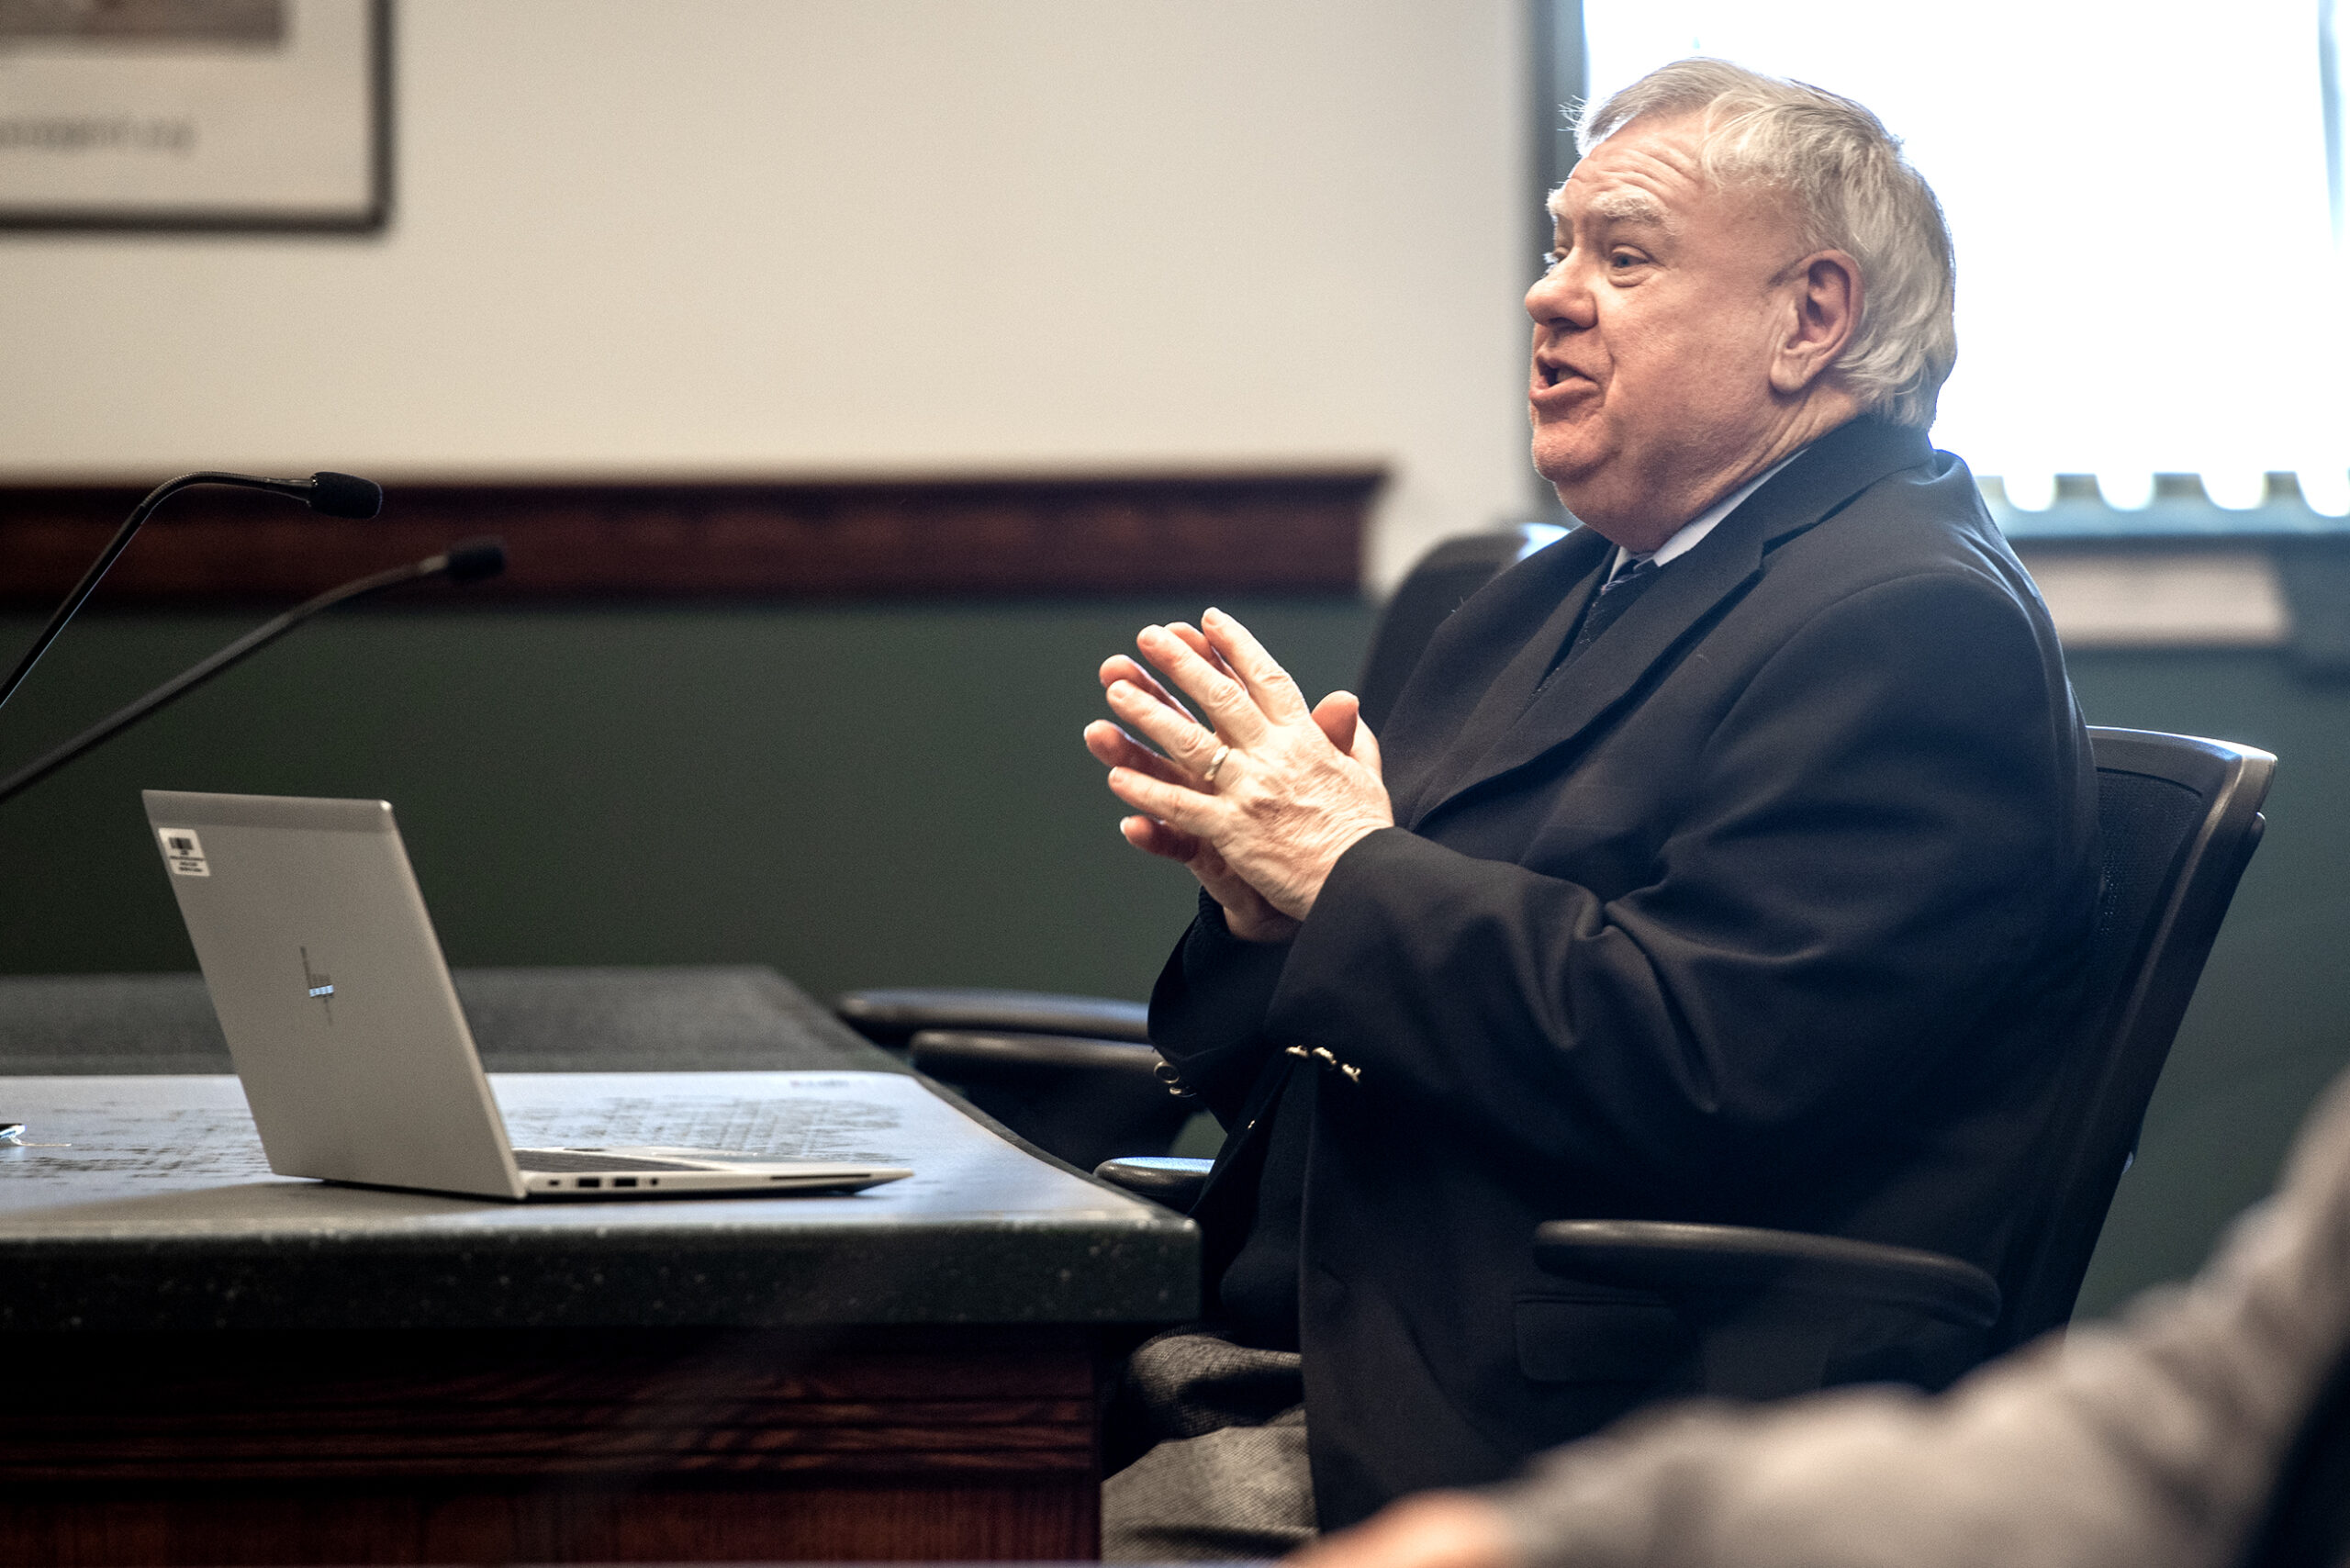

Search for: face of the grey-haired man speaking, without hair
xmin=1525 ymin=115 xmax=1797 ymax=550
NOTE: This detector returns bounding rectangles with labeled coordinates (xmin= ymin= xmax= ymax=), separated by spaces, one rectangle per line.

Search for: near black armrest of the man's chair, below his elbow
xmin=1535 ymin=1220 xmax=2000 ymax=1328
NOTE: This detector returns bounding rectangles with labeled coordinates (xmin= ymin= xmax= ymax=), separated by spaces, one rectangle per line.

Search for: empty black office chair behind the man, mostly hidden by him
xmin=834 ymin=521 xmax=1565 ymax=1166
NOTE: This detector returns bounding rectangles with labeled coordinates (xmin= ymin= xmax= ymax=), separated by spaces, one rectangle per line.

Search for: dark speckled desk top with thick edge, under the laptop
xmin=0 ymin=969 xmax=1199 ymax=1330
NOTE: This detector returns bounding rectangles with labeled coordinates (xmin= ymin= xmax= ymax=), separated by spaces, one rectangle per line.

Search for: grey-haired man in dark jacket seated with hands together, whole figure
xmin=1086 ymin=62 xmax=2097 ymax=1556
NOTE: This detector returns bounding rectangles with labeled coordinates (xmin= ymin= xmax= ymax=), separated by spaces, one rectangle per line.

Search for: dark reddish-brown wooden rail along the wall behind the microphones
xmin=0 ymin=470 xmax=1382 ymax=602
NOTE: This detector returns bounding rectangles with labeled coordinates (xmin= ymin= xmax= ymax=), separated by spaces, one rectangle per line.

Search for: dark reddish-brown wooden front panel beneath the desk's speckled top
xmin=0 ymin=1328 xmax=1100 ymax=1568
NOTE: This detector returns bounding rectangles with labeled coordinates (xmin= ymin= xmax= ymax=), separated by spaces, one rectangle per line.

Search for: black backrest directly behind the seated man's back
xmin=1990 ymin=729 xmax=2277 ymax=1354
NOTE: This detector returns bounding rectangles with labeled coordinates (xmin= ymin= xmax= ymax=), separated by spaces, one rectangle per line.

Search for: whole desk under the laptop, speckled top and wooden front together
xmin=0 ymin=971 xmax=1199 ymax=1563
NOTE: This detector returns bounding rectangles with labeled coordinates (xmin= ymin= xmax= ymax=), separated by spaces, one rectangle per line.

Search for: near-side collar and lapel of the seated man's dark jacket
xmin=1407 ymin=419 xmax=1931 ymax=827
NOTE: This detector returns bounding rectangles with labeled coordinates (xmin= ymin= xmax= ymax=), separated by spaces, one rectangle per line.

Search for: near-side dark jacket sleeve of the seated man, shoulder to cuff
xmin=1267 ymin=571 xmax=2082 ymax=1190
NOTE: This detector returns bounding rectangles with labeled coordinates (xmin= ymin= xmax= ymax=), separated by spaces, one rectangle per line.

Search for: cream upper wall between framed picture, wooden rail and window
xmin=0 ymin=0 xmax=1530 ymax=578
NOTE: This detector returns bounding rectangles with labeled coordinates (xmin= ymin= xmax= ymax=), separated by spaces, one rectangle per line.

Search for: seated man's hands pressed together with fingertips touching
xmin=1086 ymin=609 xmax=1396 ymax=943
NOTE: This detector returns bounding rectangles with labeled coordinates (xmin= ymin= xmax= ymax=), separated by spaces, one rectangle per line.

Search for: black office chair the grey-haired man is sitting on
xmin=1535 ymin=729 xmax=2277 ymax=1399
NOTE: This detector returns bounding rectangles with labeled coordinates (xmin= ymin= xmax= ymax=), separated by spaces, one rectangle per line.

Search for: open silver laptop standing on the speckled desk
xmin=143 ymin=790 xmax=912 ymax=1199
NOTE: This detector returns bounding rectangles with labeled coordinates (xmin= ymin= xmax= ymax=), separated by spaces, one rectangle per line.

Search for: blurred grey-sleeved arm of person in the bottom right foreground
xmin=1295 ymin=1074 xmax=2350 ymax=1568
